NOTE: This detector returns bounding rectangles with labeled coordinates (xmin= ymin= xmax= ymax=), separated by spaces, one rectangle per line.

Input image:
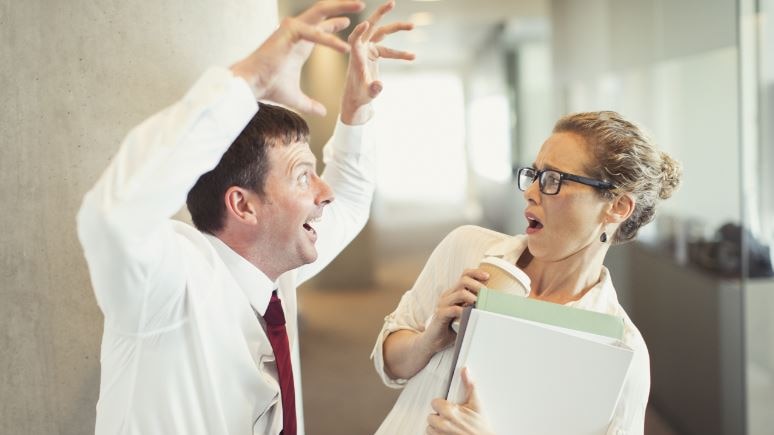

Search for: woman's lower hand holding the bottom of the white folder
xmin=427 ymin=367 xmax=494 ymax=435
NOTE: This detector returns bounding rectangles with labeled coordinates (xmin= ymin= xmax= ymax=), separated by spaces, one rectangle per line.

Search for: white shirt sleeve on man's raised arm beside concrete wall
xmin=77 ymin=68 xmax=258 ymax=333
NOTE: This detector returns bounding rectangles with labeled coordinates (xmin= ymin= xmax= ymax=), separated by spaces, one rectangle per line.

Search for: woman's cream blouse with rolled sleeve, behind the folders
xmin=371 ymin=225 xmax=650 ymax=435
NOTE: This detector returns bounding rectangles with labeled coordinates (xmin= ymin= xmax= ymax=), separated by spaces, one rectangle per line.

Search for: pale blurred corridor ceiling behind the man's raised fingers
xmin=280 ymin=0 xmax=550 ymax=67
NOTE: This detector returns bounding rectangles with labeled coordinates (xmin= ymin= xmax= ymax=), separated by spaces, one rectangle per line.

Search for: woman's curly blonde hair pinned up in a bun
xmin=554 ymin=111 xmax=682 ymax=243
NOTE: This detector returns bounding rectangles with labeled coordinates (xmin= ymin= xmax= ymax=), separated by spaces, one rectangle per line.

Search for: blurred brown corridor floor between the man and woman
xmin=299 ymin=223 xmax=678 ymax=435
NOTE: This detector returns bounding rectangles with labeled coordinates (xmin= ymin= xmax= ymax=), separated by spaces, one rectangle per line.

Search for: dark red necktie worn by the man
xmin=263 ymin=290 xmax=297 ymax=435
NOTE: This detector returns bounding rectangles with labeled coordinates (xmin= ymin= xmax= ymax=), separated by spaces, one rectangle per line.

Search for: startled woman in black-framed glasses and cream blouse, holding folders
xmin=371 ymin=112 xmax=680 ymax=434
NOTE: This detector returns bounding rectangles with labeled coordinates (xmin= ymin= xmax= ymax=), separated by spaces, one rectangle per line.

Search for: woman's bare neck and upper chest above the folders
xmin=517 ymin=246 xmax=607 ymax=304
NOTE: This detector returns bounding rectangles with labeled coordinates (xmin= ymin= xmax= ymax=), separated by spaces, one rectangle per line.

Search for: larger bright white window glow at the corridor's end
xmin=369 ymin=71 xmax=467 ymax=204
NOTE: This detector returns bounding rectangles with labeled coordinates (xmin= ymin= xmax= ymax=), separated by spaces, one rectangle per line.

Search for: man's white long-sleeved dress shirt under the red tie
xmin=78 ymin=68 xmax=374 ymax=435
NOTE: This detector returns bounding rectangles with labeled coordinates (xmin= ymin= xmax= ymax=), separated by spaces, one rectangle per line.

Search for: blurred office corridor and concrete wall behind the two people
xmin=0 ymin=0 xmax=774 ymax=435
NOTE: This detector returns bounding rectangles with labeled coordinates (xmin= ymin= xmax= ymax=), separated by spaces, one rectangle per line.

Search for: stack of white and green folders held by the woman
xmin=447 ymin=289 xmax=633 ymax=435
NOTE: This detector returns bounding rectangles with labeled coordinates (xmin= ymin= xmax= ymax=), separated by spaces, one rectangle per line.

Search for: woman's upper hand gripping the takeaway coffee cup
xmin=420 ymin=268 xmax=489 ymax=355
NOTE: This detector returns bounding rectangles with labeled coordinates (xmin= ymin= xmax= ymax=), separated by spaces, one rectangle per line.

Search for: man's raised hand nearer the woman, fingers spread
xmin=341 ymin=0 xmax=414 ymax=125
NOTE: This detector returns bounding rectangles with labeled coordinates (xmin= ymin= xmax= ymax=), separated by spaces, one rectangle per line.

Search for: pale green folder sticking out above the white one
xmin=476 ymin=288 xmax=623 ymax=340
